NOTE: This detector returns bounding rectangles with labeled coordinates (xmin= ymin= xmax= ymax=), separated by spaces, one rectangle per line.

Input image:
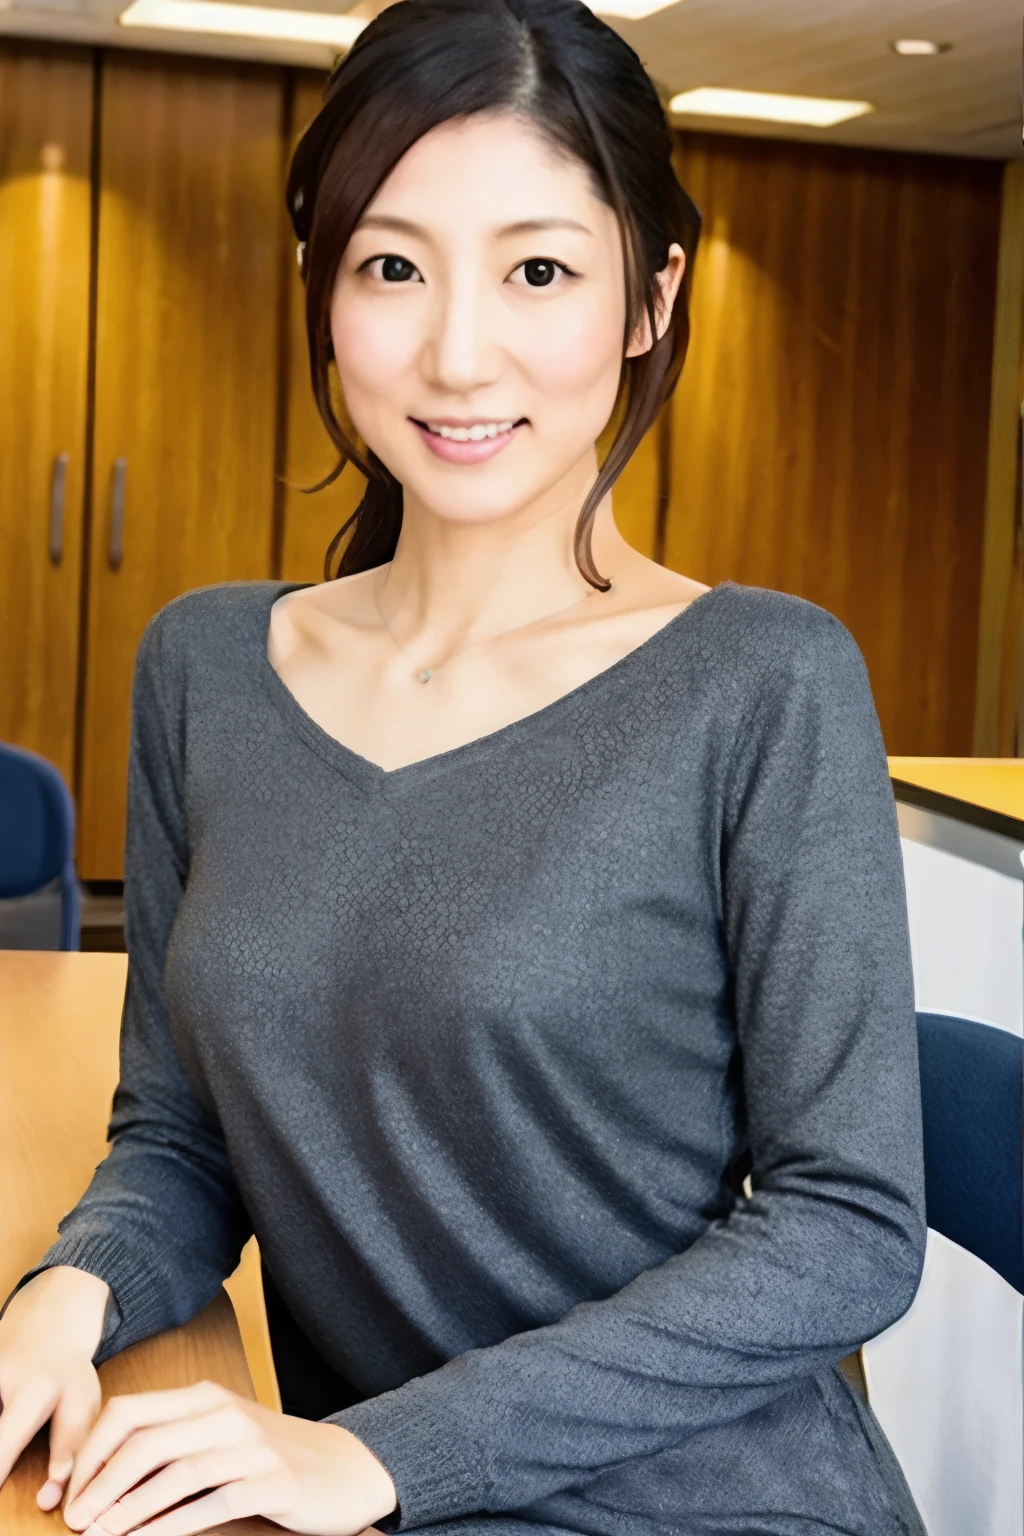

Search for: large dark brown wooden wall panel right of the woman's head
xmin=666 ymin=135 xmax=1001 ymax=756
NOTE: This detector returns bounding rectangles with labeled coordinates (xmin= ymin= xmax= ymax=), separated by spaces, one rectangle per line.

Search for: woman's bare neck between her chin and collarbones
xmin=376 ymin=448 xmax=628 ymax=656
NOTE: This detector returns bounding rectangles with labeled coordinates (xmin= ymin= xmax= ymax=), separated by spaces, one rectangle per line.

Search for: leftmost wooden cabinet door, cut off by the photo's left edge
xmin=0 ymin=43 xmax=92 ymax=783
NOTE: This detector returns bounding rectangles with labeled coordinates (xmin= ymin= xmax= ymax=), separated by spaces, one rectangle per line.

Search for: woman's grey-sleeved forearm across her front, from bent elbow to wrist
xmin=335 ymin=1173 xmax=923 ymax=1528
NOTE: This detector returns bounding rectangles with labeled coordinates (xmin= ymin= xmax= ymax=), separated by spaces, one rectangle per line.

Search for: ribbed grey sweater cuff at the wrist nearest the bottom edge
xmin=330 ymin=1373 xmax=487 ymax=1531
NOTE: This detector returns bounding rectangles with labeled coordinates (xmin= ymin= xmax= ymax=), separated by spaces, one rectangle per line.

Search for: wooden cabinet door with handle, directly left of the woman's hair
xmin=78 ymin=55 xmax=284 ymax=879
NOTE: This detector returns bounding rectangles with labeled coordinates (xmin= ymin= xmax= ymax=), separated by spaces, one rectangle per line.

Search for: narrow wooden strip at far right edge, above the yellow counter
xmin=973 ymin=161 xmax=1024 ymax=756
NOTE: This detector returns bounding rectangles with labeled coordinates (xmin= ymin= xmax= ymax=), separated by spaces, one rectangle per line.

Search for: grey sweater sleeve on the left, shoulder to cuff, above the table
xmin=26 ymin=616 xmax=250 ymax=1359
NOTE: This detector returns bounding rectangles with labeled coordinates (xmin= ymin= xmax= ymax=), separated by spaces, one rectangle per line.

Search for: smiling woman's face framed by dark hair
xmin=330 ymin=115 xmax=641 ymax=524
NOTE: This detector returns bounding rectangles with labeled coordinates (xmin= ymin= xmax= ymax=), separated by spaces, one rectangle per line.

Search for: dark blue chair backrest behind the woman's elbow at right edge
xmin=918 ymin=1014 xmax=1024 ymax=1295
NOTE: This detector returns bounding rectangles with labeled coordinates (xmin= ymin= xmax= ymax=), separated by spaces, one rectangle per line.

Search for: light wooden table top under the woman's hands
xmin=0 ymin=949 xmax=268 ymax=1536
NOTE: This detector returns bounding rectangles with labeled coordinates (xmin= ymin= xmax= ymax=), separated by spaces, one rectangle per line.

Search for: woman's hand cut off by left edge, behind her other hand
xmin=0 ymin=1264 xmax=111 ymax=1510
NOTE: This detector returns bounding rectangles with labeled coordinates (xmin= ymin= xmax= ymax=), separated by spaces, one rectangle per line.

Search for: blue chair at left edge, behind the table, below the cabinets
xmin=0 ymin=742 xmax=81 ymax=949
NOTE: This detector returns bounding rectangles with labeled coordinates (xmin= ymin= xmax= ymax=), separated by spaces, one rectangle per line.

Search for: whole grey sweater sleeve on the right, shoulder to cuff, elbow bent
xmin=335 ymin=598 xmax=924 ymax=1528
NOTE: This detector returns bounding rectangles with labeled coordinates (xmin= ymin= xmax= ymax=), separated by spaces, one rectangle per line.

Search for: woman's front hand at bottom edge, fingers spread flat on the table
xmin=64 ymin=1381 xmax=398 ymax=1536
